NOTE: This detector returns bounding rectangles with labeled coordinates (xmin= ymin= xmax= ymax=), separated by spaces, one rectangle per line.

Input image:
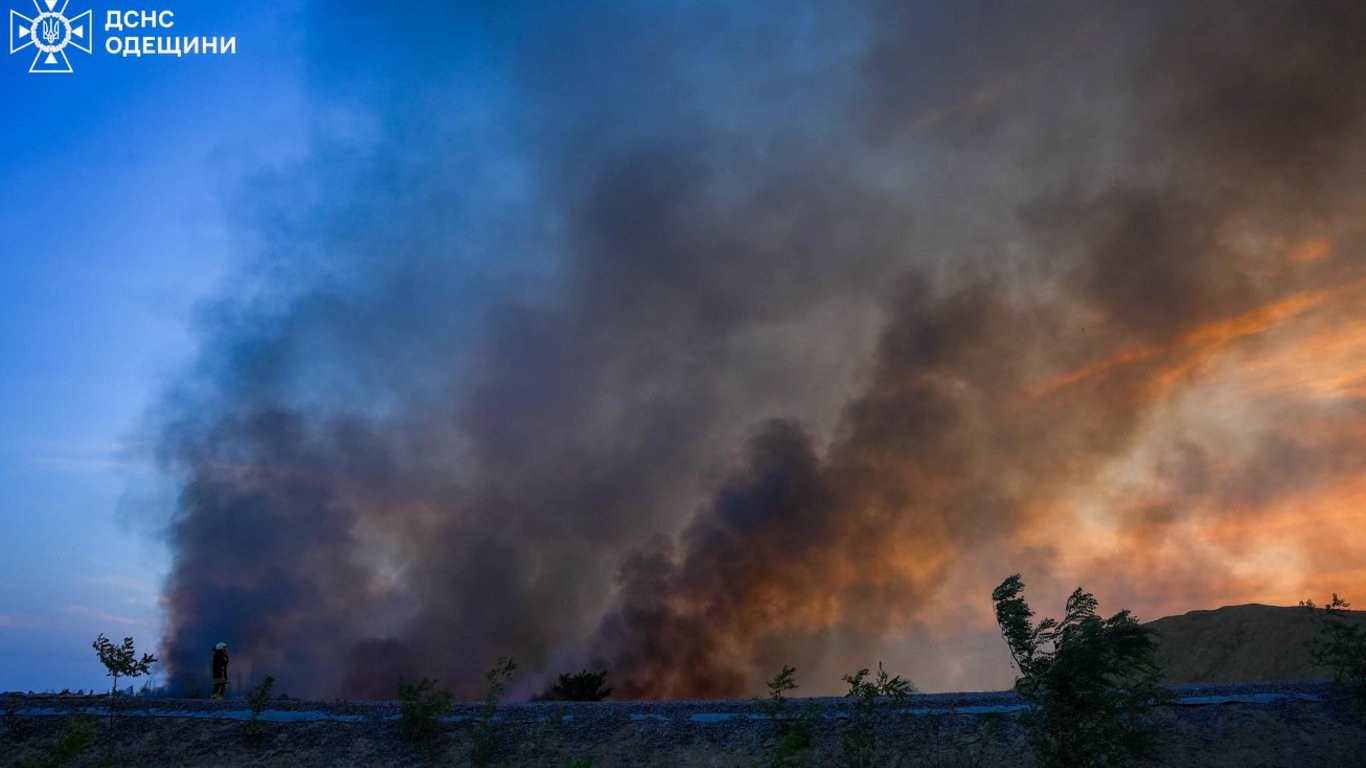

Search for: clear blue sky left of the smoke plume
xmin=0 ymin=0 xmax=306 ymax=690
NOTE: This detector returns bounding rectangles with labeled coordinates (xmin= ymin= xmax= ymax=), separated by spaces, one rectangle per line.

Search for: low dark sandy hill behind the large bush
xmin=1147 ymin=604 xmax=1366 ymax=683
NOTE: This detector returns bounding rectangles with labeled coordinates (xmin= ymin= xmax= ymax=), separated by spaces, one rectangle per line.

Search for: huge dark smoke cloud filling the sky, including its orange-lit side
xmin=2 ymin=0 xmax=1366 ymax=697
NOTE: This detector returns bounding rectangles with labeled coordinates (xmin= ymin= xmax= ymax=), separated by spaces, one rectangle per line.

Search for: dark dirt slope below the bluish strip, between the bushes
xmin=0 ymin=691 xmax=1366 ymax=768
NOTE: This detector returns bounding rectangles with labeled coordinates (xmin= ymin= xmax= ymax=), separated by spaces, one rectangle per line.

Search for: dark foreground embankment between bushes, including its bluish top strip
xmin=0 ymin=683 xmax=1366 ymax=768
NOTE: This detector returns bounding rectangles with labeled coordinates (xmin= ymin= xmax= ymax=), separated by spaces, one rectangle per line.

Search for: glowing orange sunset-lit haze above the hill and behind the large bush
xmin=893 ymin=239 xmax=1366 ymax=690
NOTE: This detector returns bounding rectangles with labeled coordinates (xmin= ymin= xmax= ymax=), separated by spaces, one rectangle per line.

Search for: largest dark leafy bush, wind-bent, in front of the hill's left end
xmin=992 ymin=574 xmax=1172 ymax=768
